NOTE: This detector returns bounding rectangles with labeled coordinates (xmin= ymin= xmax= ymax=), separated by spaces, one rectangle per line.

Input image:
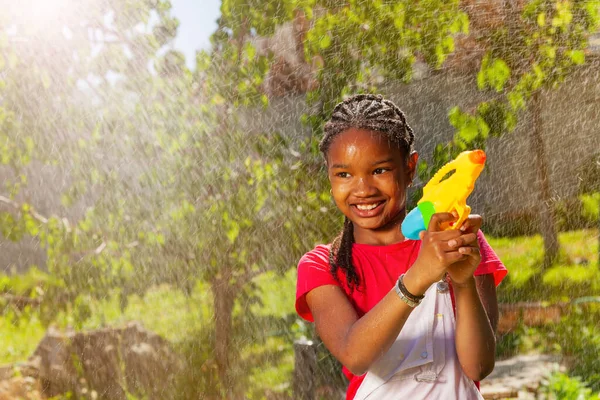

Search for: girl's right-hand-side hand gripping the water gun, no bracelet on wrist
xmin=447 ymin=215 xmax=483 ymax=286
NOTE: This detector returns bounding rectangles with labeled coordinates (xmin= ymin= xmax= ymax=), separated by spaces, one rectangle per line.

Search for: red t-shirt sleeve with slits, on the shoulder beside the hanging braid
xmin=296 ymin=245 xmax=340 ymax=322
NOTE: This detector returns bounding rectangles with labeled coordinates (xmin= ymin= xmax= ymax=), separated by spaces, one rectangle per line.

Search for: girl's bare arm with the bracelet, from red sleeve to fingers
xmin=306 ymin=213 xmax=468 ymax=375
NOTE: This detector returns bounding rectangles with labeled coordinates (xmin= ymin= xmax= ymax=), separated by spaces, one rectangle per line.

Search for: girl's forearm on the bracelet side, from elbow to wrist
xmin=340 ymin=271 xmax=427 ymax=375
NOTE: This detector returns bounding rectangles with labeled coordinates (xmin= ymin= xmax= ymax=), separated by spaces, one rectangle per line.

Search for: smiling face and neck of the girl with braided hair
xmin=327 ymin=128 xmax=418 ymax=243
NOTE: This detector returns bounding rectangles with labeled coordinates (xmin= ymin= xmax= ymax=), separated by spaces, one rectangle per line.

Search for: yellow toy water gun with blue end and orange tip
xmin=401 ymin=150 xmax=486 ymax=240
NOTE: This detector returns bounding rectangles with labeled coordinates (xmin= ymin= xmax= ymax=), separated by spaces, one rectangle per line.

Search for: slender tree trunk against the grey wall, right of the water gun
xmin=530 ymin=90 xmax=559 ymax=269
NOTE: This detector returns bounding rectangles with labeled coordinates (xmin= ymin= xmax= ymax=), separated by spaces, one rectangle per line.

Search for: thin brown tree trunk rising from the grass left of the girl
xmin=211 ymin=277 xmax=235 ymax=398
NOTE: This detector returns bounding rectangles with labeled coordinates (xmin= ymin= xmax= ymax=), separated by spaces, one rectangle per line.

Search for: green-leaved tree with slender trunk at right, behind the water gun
xmin=450 ymin=0 xmax=600 ymax=267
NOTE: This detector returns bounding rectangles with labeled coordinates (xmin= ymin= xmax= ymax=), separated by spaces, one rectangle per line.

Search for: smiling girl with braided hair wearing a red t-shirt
xmin=296 ymin=95 xmax=507 ymax=400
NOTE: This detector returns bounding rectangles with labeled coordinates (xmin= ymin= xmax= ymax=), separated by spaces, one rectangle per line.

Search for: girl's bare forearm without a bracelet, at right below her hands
xmin=453 ymin=278 xmax=496 ymax=381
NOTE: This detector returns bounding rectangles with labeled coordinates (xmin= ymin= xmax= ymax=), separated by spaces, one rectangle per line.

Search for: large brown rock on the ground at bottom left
xmin=22 ymin=323 xmax=182 ymax=400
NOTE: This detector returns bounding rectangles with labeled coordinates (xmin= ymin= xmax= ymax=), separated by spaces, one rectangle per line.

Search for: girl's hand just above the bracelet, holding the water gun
xmin=404 ymin=213 xmax=468 ymax=295
